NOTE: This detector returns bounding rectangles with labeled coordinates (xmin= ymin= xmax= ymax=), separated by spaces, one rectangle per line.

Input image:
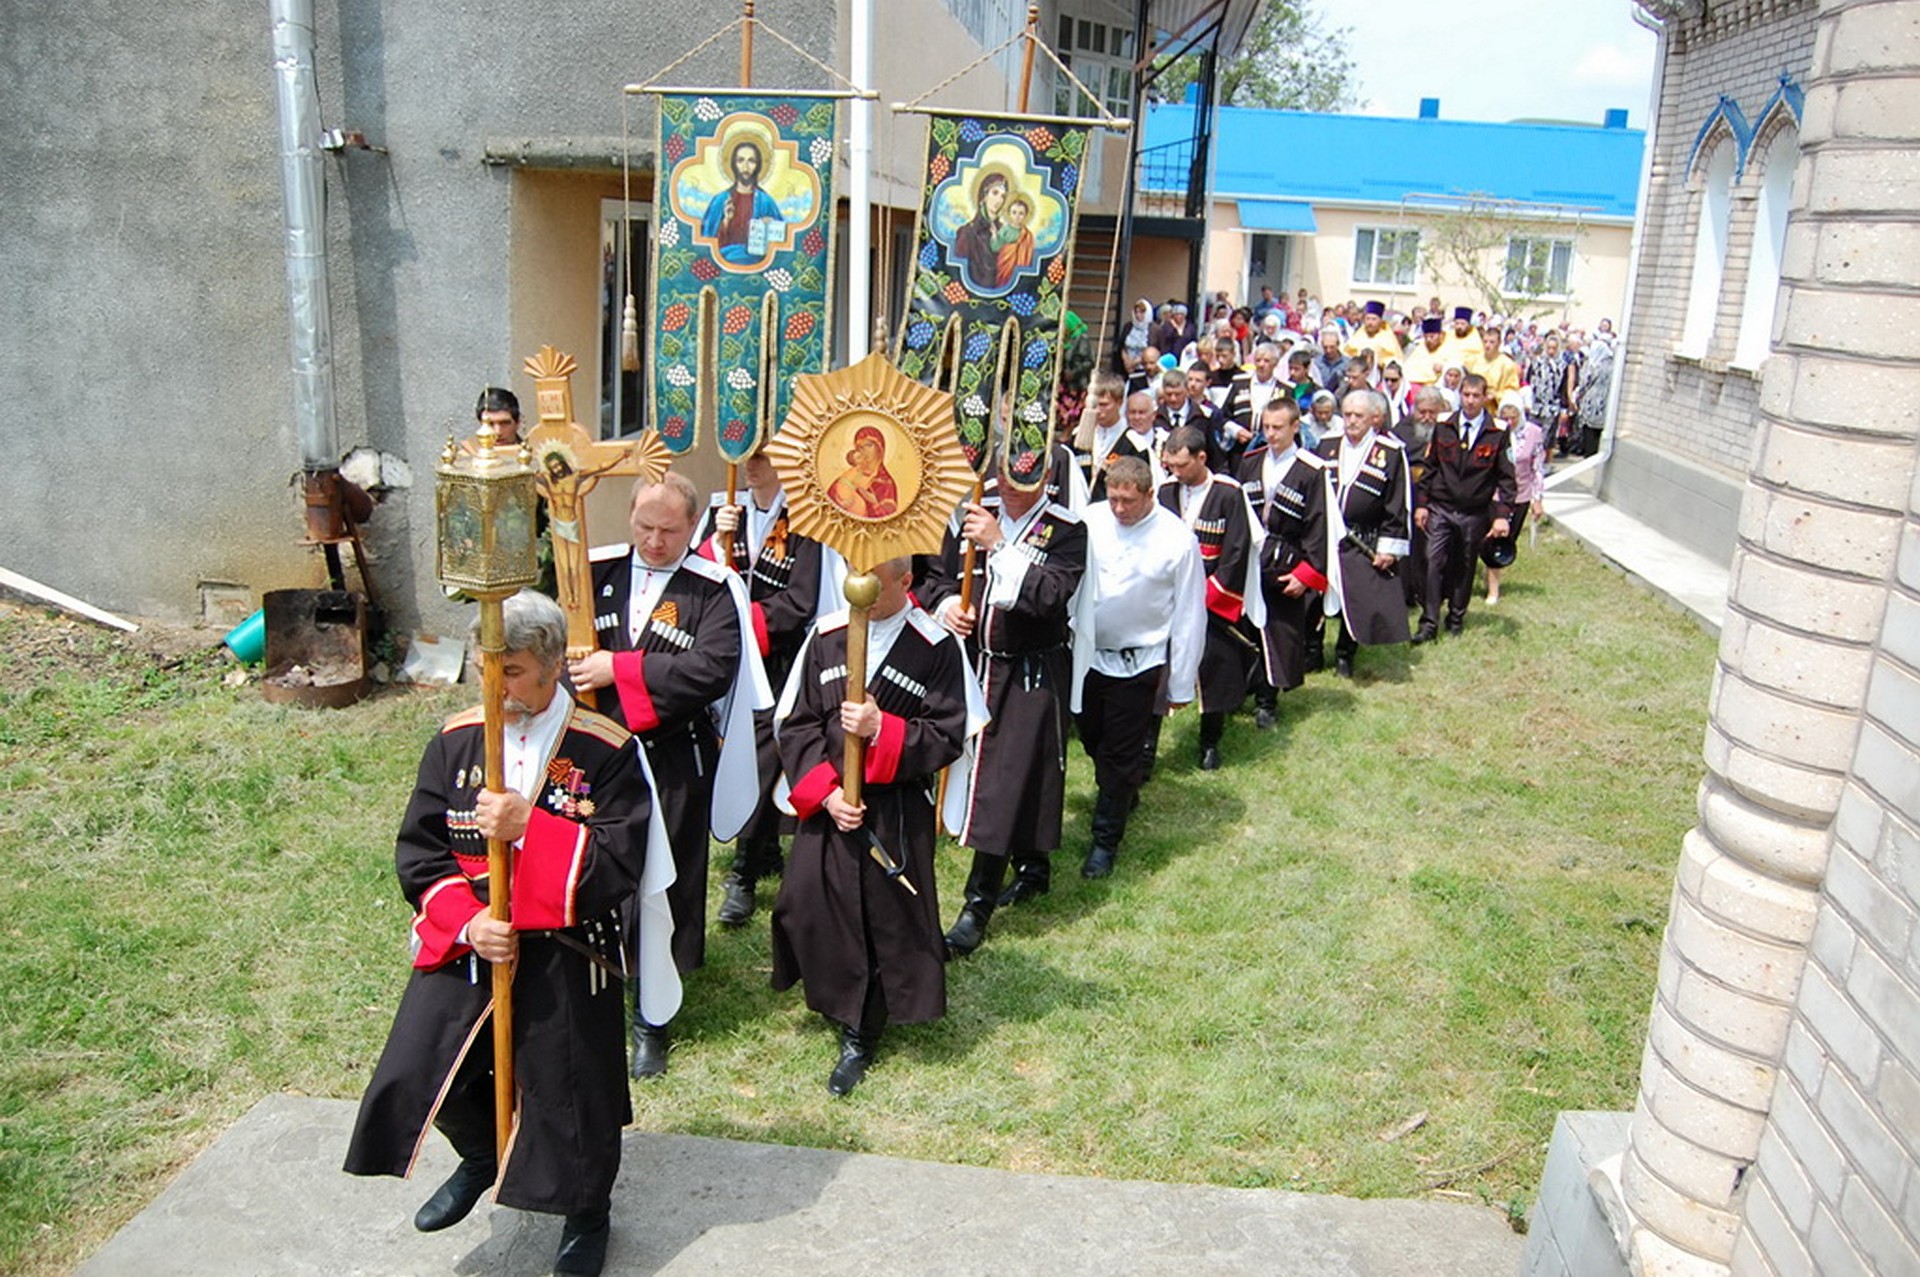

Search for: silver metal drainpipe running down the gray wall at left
xmin=269 ymin=0 xmax=340 ymax=483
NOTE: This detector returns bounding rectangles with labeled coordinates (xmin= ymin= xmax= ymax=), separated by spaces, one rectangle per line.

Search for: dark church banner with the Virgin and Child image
xmin=897 ymin=115 xmax=1089 ymax=488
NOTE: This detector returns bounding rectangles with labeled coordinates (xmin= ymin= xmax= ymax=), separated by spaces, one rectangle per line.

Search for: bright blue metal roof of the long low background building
xmin=1140 ymin=104 xmax=1645 ymax=219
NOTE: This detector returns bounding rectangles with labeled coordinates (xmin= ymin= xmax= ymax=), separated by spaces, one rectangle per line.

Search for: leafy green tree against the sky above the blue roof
xmin=1158 ymin=0 xmax=1354 ymax=111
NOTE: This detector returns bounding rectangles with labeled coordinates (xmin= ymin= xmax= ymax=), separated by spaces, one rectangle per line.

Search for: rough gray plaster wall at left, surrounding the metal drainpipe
xmin=0 ymin=0 xmax=837 ymax=624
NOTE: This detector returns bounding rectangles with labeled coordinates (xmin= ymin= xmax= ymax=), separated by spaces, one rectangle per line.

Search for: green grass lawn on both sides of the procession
xmin=0 ymin=528 xmax=1715 ymax=1273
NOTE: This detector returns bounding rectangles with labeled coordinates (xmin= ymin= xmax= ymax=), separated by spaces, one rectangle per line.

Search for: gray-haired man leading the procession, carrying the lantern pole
xmin=346 ymin=590 xmax=664 ymax=1273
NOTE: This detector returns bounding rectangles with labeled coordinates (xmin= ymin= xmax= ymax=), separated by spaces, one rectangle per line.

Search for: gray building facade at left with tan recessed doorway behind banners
xmin=0 ymin=0 xmax=1258 ymax=630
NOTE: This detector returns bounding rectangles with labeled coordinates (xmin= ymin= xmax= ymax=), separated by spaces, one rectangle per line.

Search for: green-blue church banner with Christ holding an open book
xmin=647 ymin=92 xmax=835 ymax=461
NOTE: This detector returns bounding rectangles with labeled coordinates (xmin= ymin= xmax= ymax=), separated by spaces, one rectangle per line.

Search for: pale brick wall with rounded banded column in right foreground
xmin=1619 ymin=0 xmax=1920 ymax=1275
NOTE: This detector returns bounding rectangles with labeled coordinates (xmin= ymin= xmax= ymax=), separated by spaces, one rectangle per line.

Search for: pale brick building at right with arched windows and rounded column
xmin=1526 ymin=0 xmax=1920 ymax=1277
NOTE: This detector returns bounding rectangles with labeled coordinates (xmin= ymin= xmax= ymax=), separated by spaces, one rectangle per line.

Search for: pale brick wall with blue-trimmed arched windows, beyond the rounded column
xmin=1603 ymin=0 xmax=1812 ymax=559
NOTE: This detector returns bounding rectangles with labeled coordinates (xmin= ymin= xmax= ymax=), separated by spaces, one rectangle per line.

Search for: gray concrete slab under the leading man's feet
xmin=79 ymin=1095 xmax=1523 ymax=1277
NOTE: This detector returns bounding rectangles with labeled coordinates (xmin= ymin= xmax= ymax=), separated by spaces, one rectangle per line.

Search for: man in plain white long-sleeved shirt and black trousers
xmin=1075 ymin=457 xmax=1206 ymax=878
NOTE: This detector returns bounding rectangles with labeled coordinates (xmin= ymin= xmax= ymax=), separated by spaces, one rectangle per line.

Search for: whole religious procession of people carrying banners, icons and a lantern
xmin=334 ymin=7 xmax=1607 ymax=1273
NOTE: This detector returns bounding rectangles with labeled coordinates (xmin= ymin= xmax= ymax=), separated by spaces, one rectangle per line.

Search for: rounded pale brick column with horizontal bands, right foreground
xmin=1620 ymin=0 xmax=1920 ymax=1277
